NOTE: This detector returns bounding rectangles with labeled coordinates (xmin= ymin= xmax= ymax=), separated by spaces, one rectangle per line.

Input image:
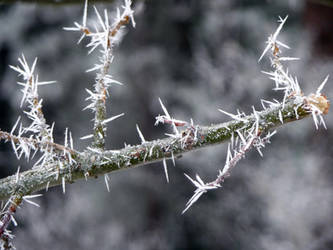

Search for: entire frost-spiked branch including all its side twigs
xmin=0 ymin=0 xmax=329 ymax=245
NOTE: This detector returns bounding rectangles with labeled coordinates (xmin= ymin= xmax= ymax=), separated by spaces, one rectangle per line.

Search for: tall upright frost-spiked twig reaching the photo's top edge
xmin=64 ymin=0 xmax=135 ymax=150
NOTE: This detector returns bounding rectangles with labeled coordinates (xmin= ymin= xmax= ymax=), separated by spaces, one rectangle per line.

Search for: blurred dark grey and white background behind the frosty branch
xmin=0 ymin=0 xmax=333 ymax=250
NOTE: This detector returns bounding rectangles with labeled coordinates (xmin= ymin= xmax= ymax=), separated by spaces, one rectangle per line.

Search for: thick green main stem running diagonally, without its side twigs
xmin=0 ymin=98 xmax=311 ymax=200
